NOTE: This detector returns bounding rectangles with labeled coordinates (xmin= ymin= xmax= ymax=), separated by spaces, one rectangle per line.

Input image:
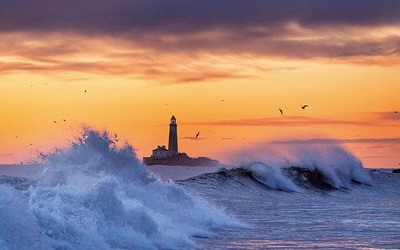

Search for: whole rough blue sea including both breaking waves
xmin=0 ymin=129 xmax=400 ymax=249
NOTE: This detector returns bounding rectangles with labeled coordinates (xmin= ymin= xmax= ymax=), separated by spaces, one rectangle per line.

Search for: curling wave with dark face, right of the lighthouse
xmin=180 ymin=146 xmax=372 ymax=193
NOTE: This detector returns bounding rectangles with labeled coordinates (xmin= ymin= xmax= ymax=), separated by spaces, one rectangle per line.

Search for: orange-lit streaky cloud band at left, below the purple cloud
xmin=0 ymin=33 xmax=284 ymax=84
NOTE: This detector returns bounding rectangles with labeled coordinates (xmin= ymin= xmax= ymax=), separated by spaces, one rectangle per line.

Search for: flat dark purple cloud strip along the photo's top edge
xmin=0 ymin=0 xmax=400 ymax=34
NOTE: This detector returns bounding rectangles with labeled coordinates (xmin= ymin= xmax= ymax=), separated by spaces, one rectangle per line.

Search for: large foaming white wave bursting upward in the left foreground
xmin=0 ymin=129 xmax=241 ymax=249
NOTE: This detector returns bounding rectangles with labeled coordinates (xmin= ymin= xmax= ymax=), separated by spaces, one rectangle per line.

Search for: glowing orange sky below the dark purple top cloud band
xmin=0 ymin=1 xmax=400 ymax=168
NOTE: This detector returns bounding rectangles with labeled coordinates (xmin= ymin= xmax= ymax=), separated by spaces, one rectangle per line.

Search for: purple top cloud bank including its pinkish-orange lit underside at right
xmin=0 ymin=0 xmax=400 ymax=58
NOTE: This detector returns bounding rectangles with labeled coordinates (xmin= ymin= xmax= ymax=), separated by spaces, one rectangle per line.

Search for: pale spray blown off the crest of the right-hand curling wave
xmin=230 ymin=142 xmax=372 ymax=191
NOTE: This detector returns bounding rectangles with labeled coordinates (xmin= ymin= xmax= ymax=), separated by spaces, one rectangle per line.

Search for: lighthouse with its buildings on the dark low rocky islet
xmin=143 ymin=116 xmax=220 ymax=166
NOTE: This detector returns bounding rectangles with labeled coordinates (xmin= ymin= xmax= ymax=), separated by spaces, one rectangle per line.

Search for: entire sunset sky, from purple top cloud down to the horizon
xmin=0 ymin=0 xmax=400 ymax=168
